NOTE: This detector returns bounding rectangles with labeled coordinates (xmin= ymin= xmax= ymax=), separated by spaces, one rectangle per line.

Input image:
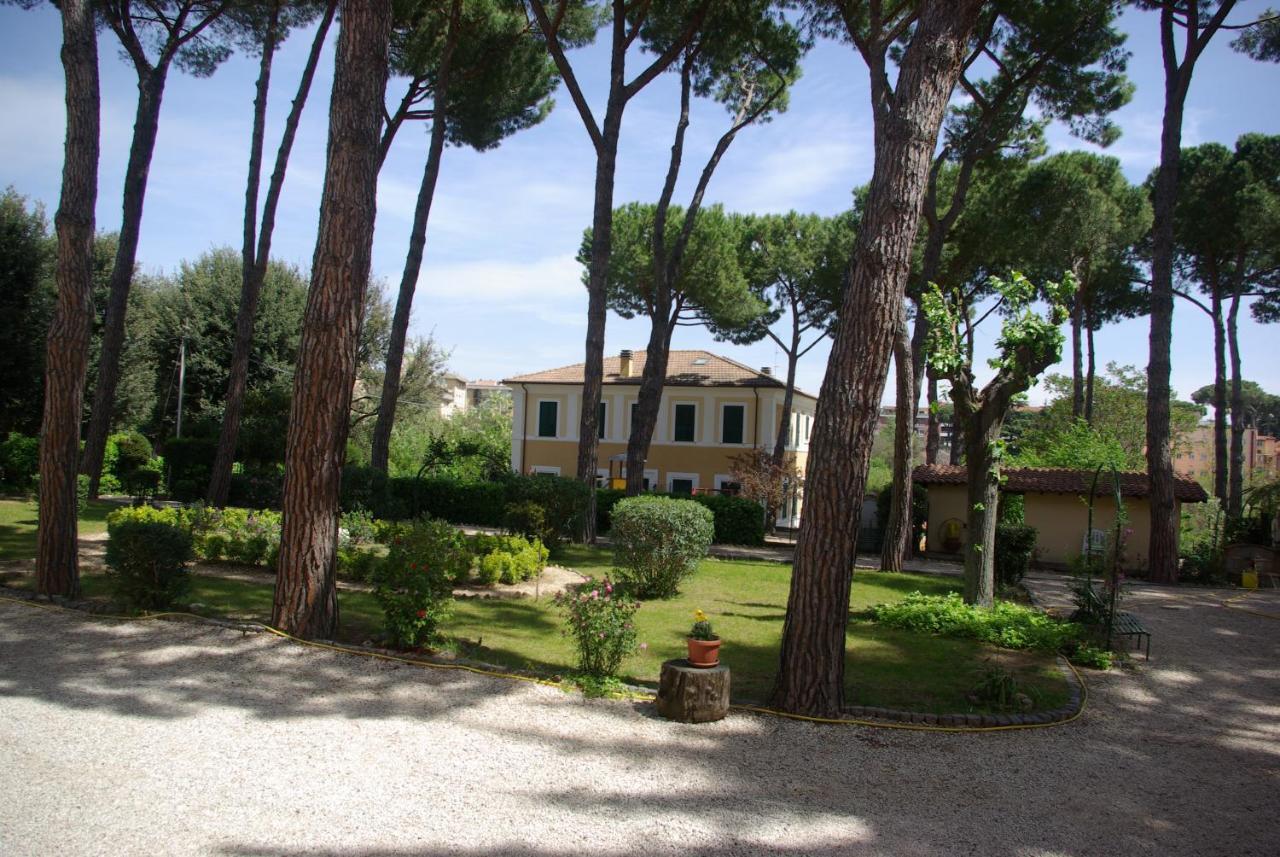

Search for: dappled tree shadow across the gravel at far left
xmin=0 ymin=605 xmax=518 ymax=719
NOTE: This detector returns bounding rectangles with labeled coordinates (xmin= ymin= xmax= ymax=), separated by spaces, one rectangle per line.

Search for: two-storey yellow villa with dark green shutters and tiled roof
xmin=503 ymin=350 xmax=818 ymax=526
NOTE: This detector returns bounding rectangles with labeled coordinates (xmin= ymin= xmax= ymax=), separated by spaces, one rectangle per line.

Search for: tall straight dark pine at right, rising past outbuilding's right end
xmin=1142 ymin=0 xmax=1280 ymax=583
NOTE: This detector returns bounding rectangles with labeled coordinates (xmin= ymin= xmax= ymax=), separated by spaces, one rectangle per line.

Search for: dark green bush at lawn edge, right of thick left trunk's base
xmin=372 ymin=522 xmax=457 ymax=647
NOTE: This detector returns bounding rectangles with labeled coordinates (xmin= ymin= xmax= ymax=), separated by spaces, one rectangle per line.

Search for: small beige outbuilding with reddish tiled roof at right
xmin=913 ymin=464 xmax=1208 ymax=570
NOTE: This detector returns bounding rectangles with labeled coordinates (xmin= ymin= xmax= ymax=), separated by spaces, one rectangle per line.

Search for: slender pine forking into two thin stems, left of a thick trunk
xmin=207 ymin=0 xmax=338 ymax=507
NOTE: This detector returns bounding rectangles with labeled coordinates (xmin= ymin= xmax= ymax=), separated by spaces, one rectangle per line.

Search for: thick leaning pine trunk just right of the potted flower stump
xmin=773 ymin=0 xmax=982 ymax=716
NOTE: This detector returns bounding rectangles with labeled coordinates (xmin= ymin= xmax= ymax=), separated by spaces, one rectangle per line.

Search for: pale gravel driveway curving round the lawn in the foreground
xmin=0 ymin=581 xmax=1280 ymax=857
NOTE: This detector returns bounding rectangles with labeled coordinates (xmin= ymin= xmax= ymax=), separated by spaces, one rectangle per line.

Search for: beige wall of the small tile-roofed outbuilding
xmin=927 ymin=485 xmax=1167 ymax=569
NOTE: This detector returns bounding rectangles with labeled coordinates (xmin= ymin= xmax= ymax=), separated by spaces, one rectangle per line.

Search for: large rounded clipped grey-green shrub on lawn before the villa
xmin=612 ymin=496 xmax=716 ymax=599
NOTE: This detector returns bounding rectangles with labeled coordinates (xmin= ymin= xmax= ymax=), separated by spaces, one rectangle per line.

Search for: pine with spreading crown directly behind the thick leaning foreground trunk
xmin=882 ymin=0 xmax=1133 ymax=570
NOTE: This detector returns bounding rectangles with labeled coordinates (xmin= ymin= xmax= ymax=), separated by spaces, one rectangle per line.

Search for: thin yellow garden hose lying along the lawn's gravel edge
xmin=0 ymin=595 xmax=1090 ymax=733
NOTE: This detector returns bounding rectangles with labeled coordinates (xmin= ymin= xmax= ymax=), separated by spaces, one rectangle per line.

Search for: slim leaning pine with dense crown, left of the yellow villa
xmin=370 ymin=0 xmax=558 ymax=472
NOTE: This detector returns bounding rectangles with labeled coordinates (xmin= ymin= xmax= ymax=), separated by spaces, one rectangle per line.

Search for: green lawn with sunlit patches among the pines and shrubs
xmin=5 ymin=546 xmax=1066 ymax=714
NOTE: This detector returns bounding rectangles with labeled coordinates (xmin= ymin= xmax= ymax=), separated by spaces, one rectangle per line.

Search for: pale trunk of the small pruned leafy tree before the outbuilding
xmin=964 ymin=404 xmax=1004 ymax=608
